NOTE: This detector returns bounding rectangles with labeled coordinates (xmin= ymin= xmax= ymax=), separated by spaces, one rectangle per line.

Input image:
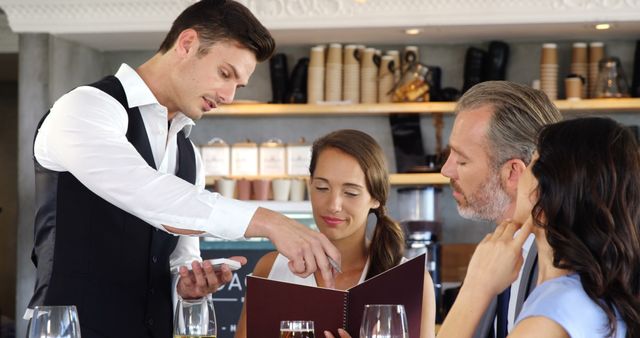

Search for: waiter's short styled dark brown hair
xmin=158 ymin=0 xmax=276 ymax=62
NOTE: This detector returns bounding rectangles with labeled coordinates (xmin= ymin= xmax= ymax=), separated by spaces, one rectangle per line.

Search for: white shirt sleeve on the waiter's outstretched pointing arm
xmin=34 ymin=86 xmax=257 ymax=240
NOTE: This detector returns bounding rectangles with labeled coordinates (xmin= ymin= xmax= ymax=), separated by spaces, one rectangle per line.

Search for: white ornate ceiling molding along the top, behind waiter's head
xmin=0 ymin=0 xmax=640 ymax=50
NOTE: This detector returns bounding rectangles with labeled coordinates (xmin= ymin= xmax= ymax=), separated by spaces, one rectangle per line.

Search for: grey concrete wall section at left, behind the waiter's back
xmin=16 ymin=34 xmax=103 ymax=337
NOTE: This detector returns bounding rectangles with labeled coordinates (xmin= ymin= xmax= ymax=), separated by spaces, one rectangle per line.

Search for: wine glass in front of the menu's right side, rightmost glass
xmin=360 ymin=304 xmax=409 ymax=338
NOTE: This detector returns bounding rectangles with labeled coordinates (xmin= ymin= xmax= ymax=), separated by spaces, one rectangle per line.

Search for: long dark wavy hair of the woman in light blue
xmin=532 ymin=118 xmax=640 ymax=338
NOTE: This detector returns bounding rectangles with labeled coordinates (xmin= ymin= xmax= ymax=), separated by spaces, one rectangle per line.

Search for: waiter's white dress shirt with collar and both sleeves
xmin=34 ymin=64 xmax=257 ymax=274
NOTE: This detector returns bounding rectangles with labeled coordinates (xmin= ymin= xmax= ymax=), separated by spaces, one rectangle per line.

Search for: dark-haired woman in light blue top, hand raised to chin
xmin=438 ymin=118 xmax=640 ymax=338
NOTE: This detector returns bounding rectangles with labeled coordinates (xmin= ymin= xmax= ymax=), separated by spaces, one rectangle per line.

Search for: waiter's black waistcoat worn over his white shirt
xmin=29 ymin=76 xmax=196 ymax=338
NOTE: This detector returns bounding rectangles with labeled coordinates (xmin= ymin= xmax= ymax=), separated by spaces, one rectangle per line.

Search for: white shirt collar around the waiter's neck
xmin=115 ymin=63 xmax=195 ymax=137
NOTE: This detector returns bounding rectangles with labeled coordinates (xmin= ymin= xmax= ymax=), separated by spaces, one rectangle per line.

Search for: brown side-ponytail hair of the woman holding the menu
xmin=309 ymin=129 xmax=404 ymax=279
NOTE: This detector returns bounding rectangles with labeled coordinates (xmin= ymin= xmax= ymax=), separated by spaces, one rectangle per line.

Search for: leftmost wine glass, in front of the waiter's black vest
xmin=27 ymin=305 xmax=81 ymax=338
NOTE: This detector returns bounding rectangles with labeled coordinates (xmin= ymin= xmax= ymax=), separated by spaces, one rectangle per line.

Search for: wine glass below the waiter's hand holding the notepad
xmin=173 ymin=297 xmax=217 ymax=338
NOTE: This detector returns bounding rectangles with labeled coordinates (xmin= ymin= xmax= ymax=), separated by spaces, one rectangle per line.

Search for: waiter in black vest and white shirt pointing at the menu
xmin=25 ymin=0 xmax=340 ymax=338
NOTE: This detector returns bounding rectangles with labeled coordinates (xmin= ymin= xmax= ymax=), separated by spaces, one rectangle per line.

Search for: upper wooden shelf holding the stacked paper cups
xmin=205 ymin=98 xmax=640 ymax=117
